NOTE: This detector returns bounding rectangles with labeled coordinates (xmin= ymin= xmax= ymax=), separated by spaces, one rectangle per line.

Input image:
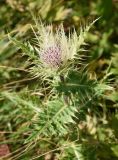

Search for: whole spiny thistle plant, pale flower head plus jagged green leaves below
xmin=3 ymin=18 xmax=111 ymax=159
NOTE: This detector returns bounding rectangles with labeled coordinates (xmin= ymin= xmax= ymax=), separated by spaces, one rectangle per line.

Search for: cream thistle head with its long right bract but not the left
xmin=33 ymin=20 xmax=96 ymax=74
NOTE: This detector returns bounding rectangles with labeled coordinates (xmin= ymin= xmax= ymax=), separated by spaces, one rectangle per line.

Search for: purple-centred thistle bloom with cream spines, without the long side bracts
xmin=36 ymin=25 xmax=78 ymax=69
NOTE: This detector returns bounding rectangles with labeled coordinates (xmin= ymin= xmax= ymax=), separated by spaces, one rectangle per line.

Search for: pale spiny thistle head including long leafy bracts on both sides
xmin=10 ymin=19 xmax=98 ymax=77
